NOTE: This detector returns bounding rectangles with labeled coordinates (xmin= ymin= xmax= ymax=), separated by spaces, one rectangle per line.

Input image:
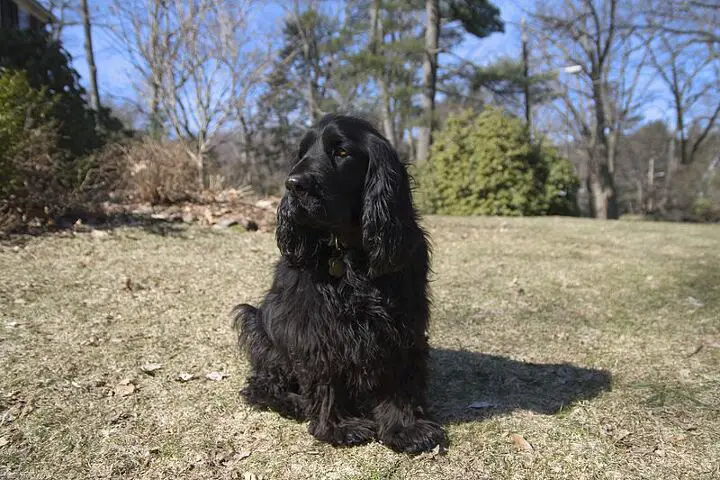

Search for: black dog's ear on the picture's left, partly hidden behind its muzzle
xmin=275 ymin=194 xmax=321 ymax=266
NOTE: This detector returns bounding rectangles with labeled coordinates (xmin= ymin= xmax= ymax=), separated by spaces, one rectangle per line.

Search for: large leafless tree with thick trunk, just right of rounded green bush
xmin=530 ymin=0 xmax=647 ymax=218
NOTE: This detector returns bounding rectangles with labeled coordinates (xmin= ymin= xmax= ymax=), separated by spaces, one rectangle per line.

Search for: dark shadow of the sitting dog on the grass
xmin=428 ymin=349 xmax=612 ymax=423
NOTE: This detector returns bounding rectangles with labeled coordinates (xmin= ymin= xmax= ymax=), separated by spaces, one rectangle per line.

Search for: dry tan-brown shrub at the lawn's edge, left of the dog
xmin=101 ymin=139 xmax=199 ymax=204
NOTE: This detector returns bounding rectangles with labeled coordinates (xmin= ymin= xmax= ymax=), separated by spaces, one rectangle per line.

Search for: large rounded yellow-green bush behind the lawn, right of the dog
xmin=414 ymin=108 xmax=578 ymax=216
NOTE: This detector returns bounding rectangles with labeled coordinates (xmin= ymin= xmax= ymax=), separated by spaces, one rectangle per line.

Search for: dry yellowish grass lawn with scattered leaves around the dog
xmin=0 ymin=218 xmax=720 ymax=480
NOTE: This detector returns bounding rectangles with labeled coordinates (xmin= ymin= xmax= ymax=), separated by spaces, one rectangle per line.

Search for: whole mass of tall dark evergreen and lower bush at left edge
xmin=0 ymin=29 xmax=127 ymax=231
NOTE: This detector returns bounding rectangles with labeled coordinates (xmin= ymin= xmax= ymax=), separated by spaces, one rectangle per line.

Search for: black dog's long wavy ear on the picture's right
xmin=362 ymin=134 xmax=422 ymax=277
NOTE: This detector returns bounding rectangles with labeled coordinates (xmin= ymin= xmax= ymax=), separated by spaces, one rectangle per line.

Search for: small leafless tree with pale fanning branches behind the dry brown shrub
xmin=114 ymin=0 xmax=267 ymax=185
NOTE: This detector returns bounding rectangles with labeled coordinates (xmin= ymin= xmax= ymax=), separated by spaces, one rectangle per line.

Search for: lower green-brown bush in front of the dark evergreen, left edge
xmin=0 ymin=70 xmax=126 ymax=232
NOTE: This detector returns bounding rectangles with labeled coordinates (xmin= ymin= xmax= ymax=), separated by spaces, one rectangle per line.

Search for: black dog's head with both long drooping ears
xmin=277 ymin=115 xmax=422 ymax=276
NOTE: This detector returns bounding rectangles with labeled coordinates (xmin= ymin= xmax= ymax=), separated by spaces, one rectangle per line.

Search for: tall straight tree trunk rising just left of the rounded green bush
xmin=416 ymin=0 xmax=440 ymax=162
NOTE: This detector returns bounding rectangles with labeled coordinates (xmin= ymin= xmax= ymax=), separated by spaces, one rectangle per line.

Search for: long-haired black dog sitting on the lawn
xmin=234 ymin=115 xmax=445 ymax=452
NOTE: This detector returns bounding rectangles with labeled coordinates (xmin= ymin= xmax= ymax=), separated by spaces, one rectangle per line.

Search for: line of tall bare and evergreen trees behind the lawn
xmin=5 ymin=0 xmax=720 ymax=223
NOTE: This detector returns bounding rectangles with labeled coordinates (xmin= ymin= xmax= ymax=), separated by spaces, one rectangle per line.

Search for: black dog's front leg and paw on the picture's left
xmin=307 ymin=383 xmax=375 ymax=446
